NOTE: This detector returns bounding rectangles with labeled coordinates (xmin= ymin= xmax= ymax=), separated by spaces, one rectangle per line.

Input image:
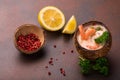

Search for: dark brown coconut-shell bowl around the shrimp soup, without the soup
xmin=74 ymin=21 xmax=112 ymax=60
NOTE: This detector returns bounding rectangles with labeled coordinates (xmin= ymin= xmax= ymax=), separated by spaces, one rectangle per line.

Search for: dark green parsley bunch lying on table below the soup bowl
xmin=79 ymin=57 xmax=109 ymax=76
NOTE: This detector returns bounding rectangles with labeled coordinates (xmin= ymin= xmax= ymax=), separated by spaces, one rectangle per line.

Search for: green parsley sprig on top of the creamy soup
xmin=95 ymin=31 xmax=109 ymax=44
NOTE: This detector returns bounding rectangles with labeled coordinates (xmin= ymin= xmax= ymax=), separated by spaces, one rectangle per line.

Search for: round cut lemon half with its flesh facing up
xmin=38 ymin=6 xmax=65 ymax=31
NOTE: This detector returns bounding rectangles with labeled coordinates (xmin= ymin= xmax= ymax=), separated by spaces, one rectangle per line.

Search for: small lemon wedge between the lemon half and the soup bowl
xmin=62 ymin=16 xmax=77 ymax=34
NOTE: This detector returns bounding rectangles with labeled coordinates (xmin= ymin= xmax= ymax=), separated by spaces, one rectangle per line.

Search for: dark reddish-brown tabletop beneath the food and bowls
xmin=0 ymin=0 xmax=120 ymax=80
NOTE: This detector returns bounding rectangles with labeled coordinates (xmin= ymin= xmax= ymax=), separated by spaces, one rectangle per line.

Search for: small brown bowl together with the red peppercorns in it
xmin=14 ymin=24 xmax=45 ymax=54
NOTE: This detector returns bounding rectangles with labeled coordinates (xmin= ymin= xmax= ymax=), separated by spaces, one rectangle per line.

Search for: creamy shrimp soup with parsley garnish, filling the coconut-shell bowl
xmin=77 ymin=24 xmax=108 ymax=50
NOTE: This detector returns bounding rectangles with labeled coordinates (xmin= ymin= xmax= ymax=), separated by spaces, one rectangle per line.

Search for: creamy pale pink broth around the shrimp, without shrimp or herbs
xmin=77 ymin=25 xmax=107 ymax=50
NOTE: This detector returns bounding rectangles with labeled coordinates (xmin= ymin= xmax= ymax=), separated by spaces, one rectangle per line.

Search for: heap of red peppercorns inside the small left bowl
xmin=17 ymin=33 xmax=41 ymax=51
